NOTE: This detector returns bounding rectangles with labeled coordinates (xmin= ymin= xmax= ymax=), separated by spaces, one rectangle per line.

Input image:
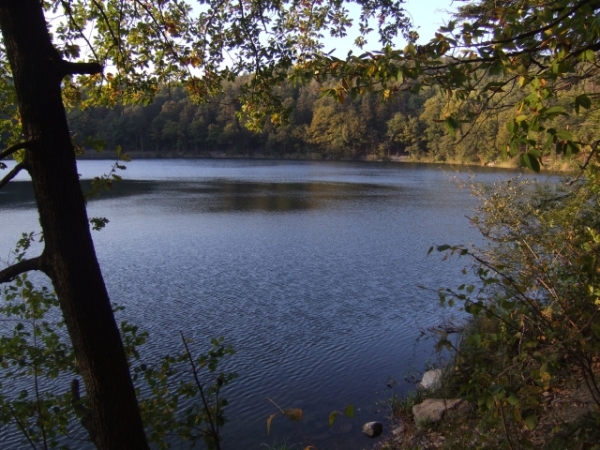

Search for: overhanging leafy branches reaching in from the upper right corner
xmin=304 ymin=0 xmax=600 ymax=171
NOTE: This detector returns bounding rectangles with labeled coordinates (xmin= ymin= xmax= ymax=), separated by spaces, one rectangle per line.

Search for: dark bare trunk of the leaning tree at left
xmin=0 ymin=0 xmax=148 ymax=449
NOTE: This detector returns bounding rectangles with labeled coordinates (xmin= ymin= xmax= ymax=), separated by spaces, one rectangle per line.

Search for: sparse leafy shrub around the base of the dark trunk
xmin=0 ymin=234 xmax=236 ymax=449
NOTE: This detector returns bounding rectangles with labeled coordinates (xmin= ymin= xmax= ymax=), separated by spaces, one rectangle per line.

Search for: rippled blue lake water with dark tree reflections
xmin=0 ymin=160 xmax=556 ymax=450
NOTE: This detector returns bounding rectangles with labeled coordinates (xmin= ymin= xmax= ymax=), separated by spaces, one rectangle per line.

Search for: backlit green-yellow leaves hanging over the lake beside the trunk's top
xmin=39 ymin=0 xmax=410 ymax=128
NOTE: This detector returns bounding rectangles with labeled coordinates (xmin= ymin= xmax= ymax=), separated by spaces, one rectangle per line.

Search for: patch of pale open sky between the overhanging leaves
xmin=325 ymin=0 xmax=456 ymax=58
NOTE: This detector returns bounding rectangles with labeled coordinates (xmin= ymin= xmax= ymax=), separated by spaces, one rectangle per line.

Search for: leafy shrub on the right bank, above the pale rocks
xmin=438 ymin=172 xmax=600 ymax=447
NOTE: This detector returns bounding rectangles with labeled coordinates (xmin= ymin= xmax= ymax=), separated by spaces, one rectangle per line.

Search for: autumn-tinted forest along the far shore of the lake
xmin=70 ymin=72 xmax=598 ymax=164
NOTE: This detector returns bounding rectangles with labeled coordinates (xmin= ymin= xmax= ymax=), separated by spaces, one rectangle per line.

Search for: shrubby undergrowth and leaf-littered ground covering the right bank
xmin=390 ymin=171 xmax=600 ymax=450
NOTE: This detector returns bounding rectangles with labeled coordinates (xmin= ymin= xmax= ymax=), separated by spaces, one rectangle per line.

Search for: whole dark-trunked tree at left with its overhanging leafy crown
xmin=0 ymin=0 xmax=407 ymax=449
